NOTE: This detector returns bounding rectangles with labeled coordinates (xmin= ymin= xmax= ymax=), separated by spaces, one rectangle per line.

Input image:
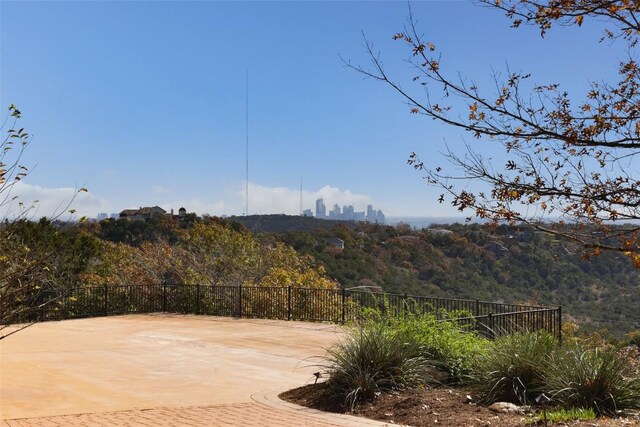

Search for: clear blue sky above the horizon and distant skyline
xmin=0 ymin=0 xmax=626 ymax=221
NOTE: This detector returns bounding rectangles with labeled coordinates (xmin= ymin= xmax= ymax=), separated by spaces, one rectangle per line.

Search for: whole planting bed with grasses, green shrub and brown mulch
xmin=281 ymin=311 xmax=640 ymax=427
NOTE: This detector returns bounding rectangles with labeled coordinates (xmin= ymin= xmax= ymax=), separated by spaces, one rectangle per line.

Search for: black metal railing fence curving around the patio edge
xmin=20 ymin=285 xmax=562 ymax=339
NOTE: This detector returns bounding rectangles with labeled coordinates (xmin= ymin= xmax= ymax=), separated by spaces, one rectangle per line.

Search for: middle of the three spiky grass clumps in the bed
xmin=475 ymin=332 xmax=556 ymax=404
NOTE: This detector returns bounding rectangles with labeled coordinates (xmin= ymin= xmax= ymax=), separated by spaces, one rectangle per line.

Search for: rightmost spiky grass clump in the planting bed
xmin=543 ymin=344 xmax=640 ymax=414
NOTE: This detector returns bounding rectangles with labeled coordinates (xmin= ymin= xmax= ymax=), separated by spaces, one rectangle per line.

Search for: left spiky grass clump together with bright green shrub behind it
xmin=325 ymin=302 xmax=488 ymax=408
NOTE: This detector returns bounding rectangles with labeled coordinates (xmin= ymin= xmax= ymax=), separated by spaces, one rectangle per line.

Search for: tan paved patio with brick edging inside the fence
xmin=0 ymin=314 xmax=390 ymax=426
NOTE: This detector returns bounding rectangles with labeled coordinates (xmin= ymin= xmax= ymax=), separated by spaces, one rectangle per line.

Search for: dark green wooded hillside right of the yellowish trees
xmin=262 ymin=223 xmax=640 ymax=335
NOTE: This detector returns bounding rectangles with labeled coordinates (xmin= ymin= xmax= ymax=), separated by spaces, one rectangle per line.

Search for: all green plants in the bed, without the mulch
xmin=326 ymin=303 xmax=640 ymax=414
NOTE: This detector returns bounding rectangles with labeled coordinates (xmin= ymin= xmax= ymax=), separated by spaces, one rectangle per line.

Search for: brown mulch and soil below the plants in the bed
xmin=279 ymin=384 xmax=640 ymax=427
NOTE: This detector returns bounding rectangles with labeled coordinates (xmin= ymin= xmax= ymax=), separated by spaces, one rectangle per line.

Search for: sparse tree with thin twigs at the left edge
xmin=0 ymin=104 xmax=88 ymax=340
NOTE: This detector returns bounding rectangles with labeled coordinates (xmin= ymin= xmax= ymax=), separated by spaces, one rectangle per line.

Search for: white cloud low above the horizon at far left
xmin=0 ymin=182 xmax=109 ymax=219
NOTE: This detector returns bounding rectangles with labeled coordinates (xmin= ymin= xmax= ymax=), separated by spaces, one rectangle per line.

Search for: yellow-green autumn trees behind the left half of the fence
xmin=83 ymin=221 xmax=336 ymax=288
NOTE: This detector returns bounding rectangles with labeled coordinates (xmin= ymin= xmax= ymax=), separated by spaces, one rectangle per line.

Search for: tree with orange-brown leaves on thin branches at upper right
xmin=347 ymin=0 xmax=640 ymax=267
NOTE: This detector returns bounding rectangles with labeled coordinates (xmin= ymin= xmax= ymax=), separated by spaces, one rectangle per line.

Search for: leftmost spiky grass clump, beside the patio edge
xmin=323 ymin=321 xmax=433 ymax=410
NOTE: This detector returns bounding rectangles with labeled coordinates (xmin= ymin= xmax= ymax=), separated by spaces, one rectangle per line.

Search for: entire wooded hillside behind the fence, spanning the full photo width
xmin=5 ymin=212 xmax=640 ymax=336
